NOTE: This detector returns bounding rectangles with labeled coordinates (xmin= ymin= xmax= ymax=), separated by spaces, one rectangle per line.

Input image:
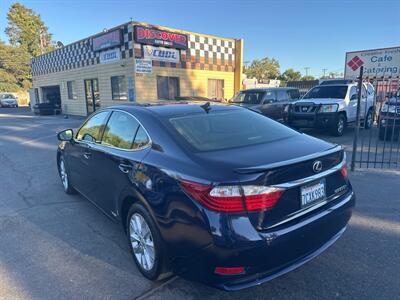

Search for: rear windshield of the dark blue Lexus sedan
xmin=169 ymin=109 xmax=298 ymax=152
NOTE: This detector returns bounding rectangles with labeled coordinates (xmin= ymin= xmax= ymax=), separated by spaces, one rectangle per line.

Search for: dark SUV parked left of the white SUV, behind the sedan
xmin=230 ymin=87 xmax=300 ymax=121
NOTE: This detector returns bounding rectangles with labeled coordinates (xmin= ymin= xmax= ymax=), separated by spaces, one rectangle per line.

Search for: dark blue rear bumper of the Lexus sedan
xmin=177 ymin=191 xmax=355 ymax=291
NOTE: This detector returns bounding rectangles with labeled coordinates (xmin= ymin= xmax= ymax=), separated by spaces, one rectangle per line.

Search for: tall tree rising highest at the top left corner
xmin=5 ymin=2 xmax=54 ymax=57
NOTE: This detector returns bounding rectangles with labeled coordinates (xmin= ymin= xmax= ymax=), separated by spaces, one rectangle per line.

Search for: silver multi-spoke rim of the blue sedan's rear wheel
xmin=129 ymin=213 xmax=156 ymax=271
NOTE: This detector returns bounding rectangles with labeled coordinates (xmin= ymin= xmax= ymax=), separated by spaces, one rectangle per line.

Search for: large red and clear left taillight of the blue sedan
xmin=181 ymin=181 xmax=284 ymax=212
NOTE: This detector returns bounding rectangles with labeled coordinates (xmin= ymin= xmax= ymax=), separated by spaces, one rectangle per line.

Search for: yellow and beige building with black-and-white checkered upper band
xmin=30 ymin=22 xmax=243 ymax=115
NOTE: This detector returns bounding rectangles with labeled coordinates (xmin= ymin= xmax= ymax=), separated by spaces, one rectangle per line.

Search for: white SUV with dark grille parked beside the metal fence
xmin=287 ymin=81 xmax=375 ymax=136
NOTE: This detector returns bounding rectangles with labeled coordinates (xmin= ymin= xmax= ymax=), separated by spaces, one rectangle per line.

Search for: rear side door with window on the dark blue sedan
xmin=92 ymin=111 xmax=150 ymax=215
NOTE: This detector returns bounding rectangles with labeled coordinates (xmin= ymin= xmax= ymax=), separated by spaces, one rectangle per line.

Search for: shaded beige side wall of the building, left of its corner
xmin=33 ymin=59 xmax=134 ymax=116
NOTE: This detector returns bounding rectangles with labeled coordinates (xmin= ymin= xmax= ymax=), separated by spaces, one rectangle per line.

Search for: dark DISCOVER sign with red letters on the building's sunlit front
xmin=135 ymin=26 xmax=187 ymax=49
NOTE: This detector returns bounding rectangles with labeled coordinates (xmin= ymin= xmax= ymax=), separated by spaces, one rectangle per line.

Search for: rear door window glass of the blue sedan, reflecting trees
xmin=102 ymin=111 xmax=139 ymax=149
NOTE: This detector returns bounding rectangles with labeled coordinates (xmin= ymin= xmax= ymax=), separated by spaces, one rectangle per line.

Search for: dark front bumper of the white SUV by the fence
xmin=288 ymin=113 xmax=338 ymax=128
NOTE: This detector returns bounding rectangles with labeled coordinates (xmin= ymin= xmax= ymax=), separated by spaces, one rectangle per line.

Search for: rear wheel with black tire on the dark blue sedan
xmin=126 ymin=203 xmax=166 ymax=280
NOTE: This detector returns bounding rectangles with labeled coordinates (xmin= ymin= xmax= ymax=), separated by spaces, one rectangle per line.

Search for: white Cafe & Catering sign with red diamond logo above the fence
xmin=344 ymin=47 xmax=400 ymax=79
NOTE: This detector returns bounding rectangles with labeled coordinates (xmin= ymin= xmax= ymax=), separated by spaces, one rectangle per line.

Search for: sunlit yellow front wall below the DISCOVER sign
xmin=135 ymin=67 xmax=234 ymax=102
